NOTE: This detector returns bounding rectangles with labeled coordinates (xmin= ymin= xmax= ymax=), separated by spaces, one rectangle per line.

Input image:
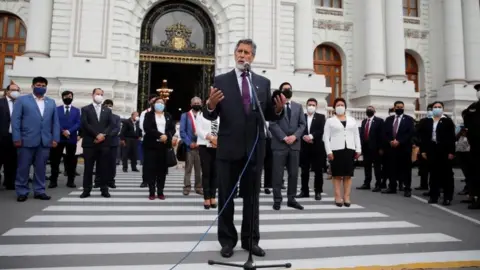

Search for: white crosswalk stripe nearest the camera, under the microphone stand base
xmin=5 ymin=251 xmax=480 ymax=270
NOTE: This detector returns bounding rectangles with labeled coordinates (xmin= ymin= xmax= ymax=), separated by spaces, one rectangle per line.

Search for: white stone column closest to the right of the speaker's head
xmin=295 ymin=0 xmax=314 ymax=73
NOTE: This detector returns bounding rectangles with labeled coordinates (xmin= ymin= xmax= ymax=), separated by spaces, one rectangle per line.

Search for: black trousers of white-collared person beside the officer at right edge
xmin=427 ymin=143 xmax=455 ymax=200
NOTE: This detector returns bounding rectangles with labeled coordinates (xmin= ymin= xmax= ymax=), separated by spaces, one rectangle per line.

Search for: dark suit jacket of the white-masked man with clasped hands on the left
xmin=80 ymin=104 xmax=114 ymax=148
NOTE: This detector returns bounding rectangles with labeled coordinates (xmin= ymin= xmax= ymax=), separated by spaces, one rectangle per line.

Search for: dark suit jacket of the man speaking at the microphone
xmin=203 ymin=70 xmax=283 ymax=162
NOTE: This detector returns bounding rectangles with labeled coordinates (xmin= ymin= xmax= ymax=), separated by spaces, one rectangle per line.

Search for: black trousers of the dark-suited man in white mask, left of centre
xmin=83 ymin=145 xmax=110 ymax=192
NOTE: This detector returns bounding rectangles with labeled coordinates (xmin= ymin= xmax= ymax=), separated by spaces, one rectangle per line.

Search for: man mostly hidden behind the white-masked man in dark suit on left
xmin=102 ymin=99 xmax=121 ymax=188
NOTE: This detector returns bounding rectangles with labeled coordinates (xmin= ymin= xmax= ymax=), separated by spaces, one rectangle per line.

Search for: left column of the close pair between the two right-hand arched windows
xmin=363 ymin=0 xmax=386 ymax=79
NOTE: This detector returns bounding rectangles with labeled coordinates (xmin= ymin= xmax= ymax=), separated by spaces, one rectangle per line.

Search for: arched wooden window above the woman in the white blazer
xmin=313 ymin=44 xmax=342 ymax=106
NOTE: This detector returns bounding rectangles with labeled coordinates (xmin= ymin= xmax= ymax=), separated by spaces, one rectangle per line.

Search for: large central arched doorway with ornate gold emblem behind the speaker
xmin=138 ymin=0 xmax=215 ymax=119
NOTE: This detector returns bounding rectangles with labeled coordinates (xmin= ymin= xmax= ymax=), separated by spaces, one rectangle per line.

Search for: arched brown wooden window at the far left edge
xmin=0 ymin=13 xmax=27 ymax=88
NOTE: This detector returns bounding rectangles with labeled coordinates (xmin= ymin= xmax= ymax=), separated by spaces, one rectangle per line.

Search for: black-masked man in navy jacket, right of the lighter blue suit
xmin=48 ymin=91 xmax=80 ymax=188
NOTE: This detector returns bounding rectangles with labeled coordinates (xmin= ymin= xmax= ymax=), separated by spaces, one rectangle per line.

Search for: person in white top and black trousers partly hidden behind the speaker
xmin=197 ymin=115 xmax=220 ymax=210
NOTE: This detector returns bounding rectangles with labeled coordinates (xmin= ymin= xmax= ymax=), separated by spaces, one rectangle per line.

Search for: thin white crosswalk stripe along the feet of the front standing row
xmin=58 ymin=194 xmax=335 ymax=204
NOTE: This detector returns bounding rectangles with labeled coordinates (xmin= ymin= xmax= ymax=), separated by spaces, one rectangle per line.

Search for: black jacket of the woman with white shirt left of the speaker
xmin=142 ymin=110 xmax=176 ymax=149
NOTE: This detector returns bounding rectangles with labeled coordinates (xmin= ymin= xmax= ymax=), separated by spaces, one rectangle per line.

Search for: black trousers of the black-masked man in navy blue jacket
xmin=50 ymin=143 xmax=77 ymax=183
